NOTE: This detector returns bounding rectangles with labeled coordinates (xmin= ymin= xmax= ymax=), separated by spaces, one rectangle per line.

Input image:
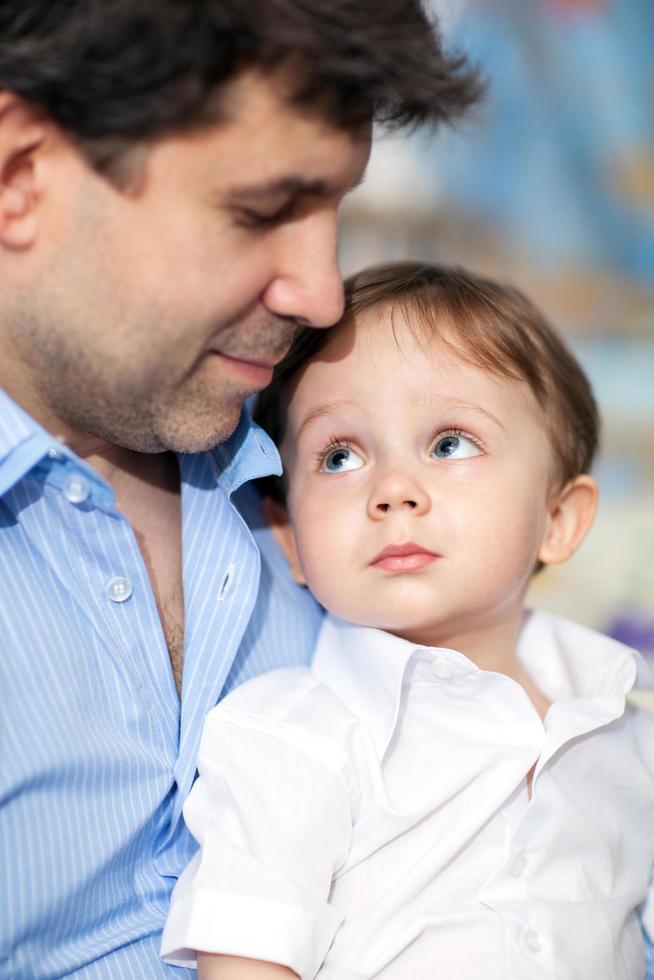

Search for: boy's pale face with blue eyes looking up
xmin=282 ymin=307 xmax=590 ymax=648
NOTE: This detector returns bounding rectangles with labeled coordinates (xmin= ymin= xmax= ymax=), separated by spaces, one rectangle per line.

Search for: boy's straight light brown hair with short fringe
xmin=254 ymin=262 xmax=599 ymax=502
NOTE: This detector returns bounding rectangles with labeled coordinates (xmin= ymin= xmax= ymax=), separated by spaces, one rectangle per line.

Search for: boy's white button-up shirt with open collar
xmin=162 ymin=613 xmax=654 ymax=980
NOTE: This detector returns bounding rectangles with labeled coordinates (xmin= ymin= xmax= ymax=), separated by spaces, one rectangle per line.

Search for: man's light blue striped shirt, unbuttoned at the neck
xmin=0 ymin=391 xmax=320 ymax=980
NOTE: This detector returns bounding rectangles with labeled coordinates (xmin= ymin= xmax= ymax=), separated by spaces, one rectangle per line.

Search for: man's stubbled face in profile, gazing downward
xmin=7 ymin=72 xmax=369 ymax=452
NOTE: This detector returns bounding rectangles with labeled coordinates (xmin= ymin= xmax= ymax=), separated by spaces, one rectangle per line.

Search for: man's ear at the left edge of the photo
xmin=0 ymin=92 xmax=46 ymax=251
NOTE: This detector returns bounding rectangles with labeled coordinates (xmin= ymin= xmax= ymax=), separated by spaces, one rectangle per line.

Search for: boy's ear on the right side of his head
xmin=538 ymin=473 xmax=598 ymax=565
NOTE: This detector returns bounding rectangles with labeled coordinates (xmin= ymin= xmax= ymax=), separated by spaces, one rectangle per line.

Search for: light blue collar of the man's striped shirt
xmin=0 ymin=389 xmax=282 ymax=502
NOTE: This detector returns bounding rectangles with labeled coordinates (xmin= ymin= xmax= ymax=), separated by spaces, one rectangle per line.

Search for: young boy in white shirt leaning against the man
xmin=162 ymin=263 xmax=654 ymax=980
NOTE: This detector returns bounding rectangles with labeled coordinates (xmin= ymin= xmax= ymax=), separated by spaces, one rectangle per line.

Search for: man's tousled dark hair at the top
xmin=0 ymin=0 xmax=482 ymax=172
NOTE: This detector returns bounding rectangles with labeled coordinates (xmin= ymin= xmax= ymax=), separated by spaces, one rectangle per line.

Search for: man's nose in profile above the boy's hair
xmin=263 ymin=210 xmax=343 ymax=327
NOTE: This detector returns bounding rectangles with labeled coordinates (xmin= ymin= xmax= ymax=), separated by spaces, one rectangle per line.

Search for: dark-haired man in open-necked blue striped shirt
xmin=0 ymin=0 xmax=479 ymax=980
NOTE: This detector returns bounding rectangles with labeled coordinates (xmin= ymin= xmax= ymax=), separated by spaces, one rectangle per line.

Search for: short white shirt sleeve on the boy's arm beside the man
xmin=161 ymin=678 xmax=352 ymax=980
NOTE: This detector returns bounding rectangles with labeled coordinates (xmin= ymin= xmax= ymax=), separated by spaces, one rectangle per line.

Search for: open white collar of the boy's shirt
xmin=312 ymin=611 xmax=654 ymax=759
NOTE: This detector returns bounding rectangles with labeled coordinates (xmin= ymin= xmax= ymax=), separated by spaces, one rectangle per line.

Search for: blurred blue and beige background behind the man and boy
xmin=341 ymin=0 xmax=654 ymax=660
